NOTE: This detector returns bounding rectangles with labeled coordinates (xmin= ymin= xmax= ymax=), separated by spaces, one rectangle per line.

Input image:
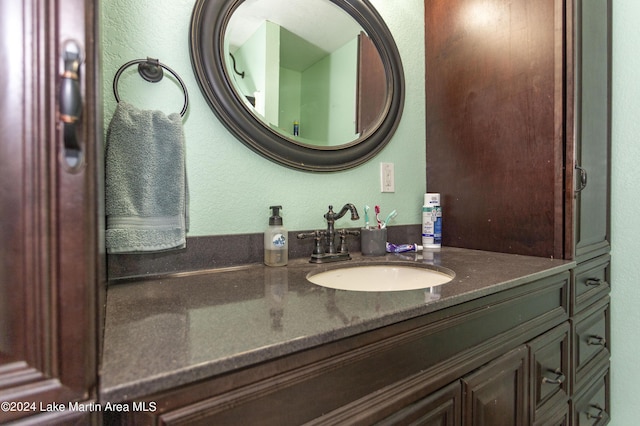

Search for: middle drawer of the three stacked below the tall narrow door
xmin=573 ymin=296 xmax=610 ymax=393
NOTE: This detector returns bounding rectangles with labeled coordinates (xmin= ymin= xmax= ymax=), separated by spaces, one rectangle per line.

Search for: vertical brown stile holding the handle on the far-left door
xmin=55 ymin=0 xmax=104 ymax=392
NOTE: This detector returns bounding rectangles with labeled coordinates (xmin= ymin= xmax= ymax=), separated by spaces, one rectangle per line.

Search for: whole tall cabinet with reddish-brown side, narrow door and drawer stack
xmin=425 ymin=0 xmax=612 ymax=425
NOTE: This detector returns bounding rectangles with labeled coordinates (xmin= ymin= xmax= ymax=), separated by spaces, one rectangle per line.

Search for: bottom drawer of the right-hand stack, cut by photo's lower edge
xmin=572 ymin=365 xmax=609 ymax=426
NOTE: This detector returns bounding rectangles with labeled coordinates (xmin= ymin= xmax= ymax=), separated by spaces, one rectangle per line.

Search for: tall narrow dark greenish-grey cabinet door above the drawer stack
xmin=573 ymin=0 xmax=611 ymax=261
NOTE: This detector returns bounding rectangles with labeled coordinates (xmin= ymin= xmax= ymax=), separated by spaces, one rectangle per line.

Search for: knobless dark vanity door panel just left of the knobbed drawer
xmin=462 ymin=346 xmax=529 ymax=426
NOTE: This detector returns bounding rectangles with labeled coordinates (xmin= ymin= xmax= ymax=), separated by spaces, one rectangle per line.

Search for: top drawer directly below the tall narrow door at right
xmin=571 ymin=255 xmax=611 ymax=315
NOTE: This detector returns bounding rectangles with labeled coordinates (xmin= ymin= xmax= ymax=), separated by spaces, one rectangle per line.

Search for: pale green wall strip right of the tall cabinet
xmin=610 ymin=0 xmax=640 ymax=426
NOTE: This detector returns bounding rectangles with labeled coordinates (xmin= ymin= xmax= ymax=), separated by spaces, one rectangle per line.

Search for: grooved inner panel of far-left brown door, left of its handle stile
xmin=0 ymin=2 xmax=52 ymax=380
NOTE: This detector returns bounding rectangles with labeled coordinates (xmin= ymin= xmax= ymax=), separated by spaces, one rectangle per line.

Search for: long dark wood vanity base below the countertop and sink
xmin=110 ymin=272 xmax=570 ymax=425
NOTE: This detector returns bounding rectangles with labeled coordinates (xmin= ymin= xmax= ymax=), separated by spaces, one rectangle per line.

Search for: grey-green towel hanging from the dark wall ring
xmin=105 ymin=101 xmax=188 ymax=253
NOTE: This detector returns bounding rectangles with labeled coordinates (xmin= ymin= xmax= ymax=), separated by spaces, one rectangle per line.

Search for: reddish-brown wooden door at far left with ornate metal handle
xmin=0 ymin=0 xmax=99 ymax=424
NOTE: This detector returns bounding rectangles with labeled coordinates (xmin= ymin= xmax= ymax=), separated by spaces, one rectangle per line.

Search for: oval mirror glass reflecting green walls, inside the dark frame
xmin=224 ymin=0 xmax=388 ymax=148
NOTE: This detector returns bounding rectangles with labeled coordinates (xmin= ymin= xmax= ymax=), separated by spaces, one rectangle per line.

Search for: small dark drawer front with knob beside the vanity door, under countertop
xmin=528 ymin=322 xmax=571 ymax=421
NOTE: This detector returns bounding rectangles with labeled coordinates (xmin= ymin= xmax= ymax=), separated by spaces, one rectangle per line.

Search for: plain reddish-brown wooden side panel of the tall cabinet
xmin=424 ymin=0 xmax=565 ymax=258
